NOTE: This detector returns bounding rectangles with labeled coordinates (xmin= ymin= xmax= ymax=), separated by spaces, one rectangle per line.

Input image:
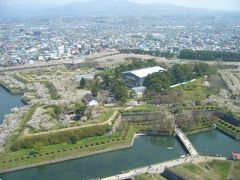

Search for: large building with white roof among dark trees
xmin=122 ymin=66 xmax=166 ymax=87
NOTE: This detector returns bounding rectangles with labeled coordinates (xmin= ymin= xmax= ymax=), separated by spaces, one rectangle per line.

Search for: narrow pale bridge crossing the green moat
xmin=175 ymin=127 xmax=198 ymax=156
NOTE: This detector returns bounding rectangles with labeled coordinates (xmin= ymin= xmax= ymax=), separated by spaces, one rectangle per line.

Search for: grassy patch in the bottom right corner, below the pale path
xmin=171 ymin=161 xmax=240 ymax=180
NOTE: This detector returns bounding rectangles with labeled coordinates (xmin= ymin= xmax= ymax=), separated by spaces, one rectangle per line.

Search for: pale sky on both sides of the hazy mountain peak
xmin=0 ymin=0 xmax=240 ymax=11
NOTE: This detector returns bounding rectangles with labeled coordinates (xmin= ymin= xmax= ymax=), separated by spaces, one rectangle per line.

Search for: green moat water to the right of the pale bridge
xmin=189 ymin=129 xmax=240 ymax=156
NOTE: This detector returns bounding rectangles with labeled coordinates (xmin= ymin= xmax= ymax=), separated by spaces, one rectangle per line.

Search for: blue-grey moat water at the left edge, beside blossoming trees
xmin=0 ymin=86 xmax=24 ymax=124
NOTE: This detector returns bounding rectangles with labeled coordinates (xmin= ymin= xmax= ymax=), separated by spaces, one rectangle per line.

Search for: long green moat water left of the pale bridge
xmin=0 ymin=136 xmax=185 ymax=180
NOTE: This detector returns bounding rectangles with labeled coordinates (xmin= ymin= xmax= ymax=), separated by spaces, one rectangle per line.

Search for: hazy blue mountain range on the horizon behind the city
xmin=0 ymin=0 xmax=237 ymax=17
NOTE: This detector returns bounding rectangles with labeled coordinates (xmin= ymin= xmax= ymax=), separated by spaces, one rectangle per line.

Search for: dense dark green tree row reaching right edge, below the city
xmin=178 ymin=49 xmax=240 ymax=62
